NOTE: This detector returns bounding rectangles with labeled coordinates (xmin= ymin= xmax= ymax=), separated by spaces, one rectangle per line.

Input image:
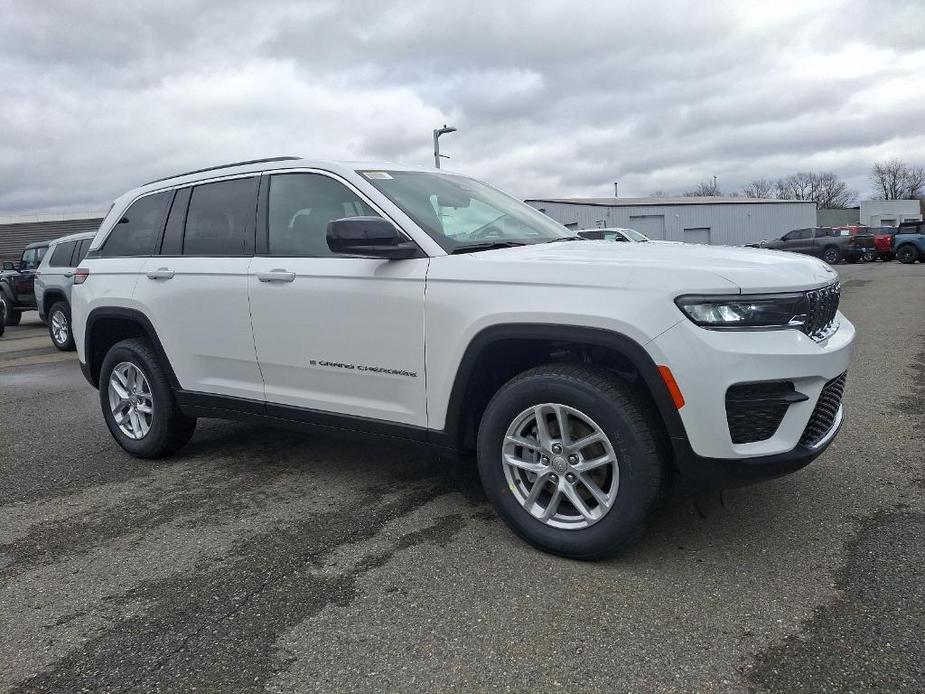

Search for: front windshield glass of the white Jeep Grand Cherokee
xmin=357 ymin=171 xmax=575 ymax=253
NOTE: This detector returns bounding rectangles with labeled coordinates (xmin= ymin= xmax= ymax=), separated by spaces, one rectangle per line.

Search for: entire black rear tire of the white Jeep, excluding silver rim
xmin=100 ymin=338 xmax=196 ymax=458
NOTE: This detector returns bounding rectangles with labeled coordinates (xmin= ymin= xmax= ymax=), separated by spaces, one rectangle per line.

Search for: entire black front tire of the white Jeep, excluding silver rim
xmin=478 ymin=364 xmax=670 ymax=559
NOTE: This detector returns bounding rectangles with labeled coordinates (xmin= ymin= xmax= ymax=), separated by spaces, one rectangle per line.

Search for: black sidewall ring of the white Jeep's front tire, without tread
xmin=478 ymin=377 xmax=653 ymax=558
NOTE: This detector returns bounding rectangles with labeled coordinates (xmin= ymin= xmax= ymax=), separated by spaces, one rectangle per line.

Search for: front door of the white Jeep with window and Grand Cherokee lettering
xmin=248 ymin=173 xmax=429 ymax=427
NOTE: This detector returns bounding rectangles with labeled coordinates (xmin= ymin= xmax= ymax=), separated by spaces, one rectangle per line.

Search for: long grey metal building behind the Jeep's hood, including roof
xmin=526 ymin=197 xmax=816 ymax=246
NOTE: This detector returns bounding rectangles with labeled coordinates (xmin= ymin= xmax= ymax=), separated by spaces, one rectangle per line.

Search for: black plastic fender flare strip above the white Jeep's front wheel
xmin=440 ymin=323 xmax=687 ymax=446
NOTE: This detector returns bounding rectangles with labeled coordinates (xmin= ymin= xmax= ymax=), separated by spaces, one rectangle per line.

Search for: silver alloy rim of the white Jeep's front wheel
xmin=501 ymin=403 xmax=620 ymax=530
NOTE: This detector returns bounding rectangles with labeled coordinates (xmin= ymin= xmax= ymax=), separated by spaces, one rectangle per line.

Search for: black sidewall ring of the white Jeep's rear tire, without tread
xmin=100 ymin=341 xmax=173 ymax=458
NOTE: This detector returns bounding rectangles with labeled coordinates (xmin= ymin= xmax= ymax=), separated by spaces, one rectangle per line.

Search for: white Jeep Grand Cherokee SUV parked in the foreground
xmin=73 ymin=157 xmax=854 ymax=558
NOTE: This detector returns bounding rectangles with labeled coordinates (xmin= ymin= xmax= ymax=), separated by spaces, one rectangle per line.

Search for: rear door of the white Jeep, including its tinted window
xmin=133 ymin=176 xmax=263 ymax=402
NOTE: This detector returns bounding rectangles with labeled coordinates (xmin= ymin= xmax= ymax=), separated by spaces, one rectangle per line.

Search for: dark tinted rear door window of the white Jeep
xmin=183 ymin=178 xmax=257 ymax=256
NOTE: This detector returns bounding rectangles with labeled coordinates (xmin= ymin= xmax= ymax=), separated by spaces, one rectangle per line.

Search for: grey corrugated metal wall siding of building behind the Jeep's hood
xmin=528 ymin=200 xmax=816 ymax=246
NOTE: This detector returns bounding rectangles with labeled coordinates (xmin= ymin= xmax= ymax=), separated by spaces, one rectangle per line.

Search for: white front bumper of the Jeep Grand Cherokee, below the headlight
xmin=646 ymin=313 xmax=855 ymax=468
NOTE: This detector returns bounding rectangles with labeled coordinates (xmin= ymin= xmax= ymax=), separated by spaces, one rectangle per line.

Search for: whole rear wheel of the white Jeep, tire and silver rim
xmin=100 ymin=338 xmax=196 ymax=458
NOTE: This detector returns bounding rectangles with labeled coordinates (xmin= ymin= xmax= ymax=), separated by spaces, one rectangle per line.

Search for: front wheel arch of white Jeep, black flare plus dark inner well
xmin=434 ymin=323 xmax=687 ymax=450
